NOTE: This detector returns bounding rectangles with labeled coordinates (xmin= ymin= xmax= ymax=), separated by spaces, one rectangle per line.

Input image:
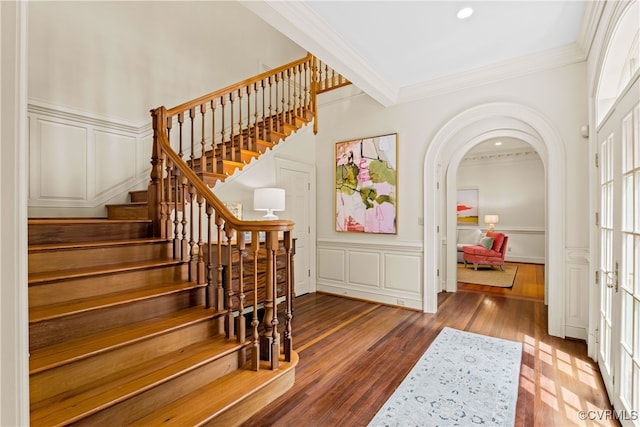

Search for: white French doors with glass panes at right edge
xmin=597 ymin=81 xmax=640 ymax=425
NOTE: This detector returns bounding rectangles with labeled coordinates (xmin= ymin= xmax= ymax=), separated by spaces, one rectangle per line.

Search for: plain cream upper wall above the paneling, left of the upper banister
xmin=29 ymin=1 xmax=306 ymax=123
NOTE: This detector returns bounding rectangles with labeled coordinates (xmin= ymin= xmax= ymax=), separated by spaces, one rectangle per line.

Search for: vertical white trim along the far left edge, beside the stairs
xmin=0 ymin=1 xmax=29 ymax=426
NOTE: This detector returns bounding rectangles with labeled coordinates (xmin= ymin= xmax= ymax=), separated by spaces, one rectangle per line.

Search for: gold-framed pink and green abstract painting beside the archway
xmin=335 ymin=133 xmax=398 ymax=234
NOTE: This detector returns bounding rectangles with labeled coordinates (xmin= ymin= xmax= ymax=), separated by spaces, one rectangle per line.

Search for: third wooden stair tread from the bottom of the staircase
xmin=29 ymin=306 xmax=218 ymax=374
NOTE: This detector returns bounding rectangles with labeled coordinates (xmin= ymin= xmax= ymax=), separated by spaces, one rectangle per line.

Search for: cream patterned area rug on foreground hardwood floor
xmin=369 ymin=327 xmax=522 ymax=427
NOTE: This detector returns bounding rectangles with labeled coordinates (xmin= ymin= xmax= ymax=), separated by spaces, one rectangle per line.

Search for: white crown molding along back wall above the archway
xmin=398 ymin=43 xmax=586 ymax=103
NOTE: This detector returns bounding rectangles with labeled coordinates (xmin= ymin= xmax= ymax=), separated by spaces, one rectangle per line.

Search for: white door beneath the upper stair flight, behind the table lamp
xmin=278 ymin=161 xmax=315 ymax=296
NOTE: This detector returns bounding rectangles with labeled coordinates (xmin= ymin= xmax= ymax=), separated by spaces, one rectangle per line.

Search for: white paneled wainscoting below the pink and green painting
xmin=317 ymin=239 xmax=423 ymax=310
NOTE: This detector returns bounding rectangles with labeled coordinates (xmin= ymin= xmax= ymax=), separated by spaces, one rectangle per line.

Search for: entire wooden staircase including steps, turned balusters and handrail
xmin=28 ymin=51 xmax=348 ymax=426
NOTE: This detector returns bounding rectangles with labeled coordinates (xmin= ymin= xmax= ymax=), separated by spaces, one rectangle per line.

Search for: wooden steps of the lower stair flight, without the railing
xmin=29 ymin=219 xmax=296 ymax=426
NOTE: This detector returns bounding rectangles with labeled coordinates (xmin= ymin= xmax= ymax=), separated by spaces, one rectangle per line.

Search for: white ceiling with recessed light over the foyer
xmin=243 ymin=0 xmax=588 ymax=105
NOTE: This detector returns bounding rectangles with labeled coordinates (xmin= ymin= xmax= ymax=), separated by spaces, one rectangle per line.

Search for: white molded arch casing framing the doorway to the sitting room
xmin=423 ymin=103 xmax=565 ymax=337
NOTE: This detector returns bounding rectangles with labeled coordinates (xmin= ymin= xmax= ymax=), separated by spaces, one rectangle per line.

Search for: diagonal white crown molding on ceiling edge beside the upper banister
xmin=240 ymin=0 xmax=398 ymax=107
